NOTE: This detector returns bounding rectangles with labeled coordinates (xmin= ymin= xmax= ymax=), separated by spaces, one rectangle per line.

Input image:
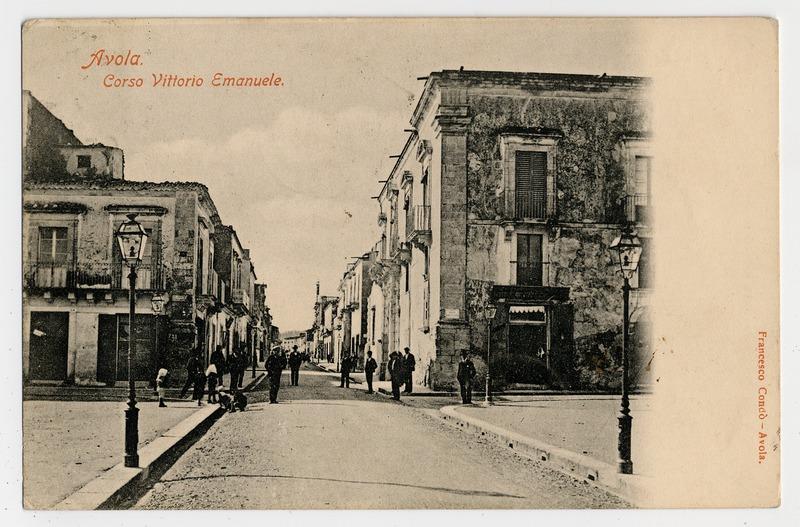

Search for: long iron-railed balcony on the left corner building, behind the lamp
xmin=25 ymin=262 xmax=166 ymax=291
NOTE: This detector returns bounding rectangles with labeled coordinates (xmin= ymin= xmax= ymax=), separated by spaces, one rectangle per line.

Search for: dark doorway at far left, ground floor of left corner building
xmin=29 ymin=311 xmax=69 ymax=381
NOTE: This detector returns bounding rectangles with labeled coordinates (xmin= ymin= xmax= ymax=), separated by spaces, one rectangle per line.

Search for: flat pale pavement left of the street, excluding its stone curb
xmin=22 ymin=401 xmax=198 ymax=509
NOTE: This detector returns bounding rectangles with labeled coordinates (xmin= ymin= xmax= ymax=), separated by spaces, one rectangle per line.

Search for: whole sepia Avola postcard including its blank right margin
xmin=20 ymin=18 xmax=780 ymax=510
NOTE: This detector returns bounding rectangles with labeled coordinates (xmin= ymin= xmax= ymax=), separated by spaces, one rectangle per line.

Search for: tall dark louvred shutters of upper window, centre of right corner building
xmin=514 ymin=151 xmax=547 ymax=218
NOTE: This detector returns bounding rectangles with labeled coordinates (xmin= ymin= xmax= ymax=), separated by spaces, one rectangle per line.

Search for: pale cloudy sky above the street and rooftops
xmin=23 ymin=19 xmax=647 ymax=331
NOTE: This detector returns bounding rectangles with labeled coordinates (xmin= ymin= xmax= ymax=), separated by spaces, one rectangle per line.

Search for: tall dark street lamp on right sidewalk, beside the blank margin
xmin=611 ymin=225 xmax=642 ymax=474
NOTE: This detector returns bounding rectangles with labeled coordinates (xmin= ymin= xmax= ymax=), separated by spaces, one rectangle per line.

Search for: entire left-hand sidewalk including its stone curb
xmin=23 ymin=370 xmax=263 ymax=510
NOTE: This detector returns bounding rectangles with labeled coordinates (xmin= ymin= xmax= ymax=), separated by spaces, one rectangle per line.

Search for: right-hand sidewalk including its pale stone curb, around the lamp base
xmin=441 ymin=395 xmax=654 ymax=502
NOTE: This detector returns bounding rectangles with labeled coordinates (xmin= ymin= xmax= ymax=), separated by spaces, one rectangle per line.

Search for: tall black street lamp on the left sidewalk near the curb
xmin=117 ymin=214 xmax=147 ymax=467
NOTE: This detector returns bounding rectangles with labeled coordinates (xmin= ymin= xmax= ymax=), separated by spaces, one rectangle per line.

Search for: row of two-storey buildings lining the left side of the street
xmin=22 ymin=91 xmax=278 ymax=386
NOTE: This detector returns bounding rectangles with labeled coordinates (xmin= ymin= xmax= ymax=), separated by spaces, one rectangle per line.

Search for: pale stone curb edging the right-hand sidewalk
xmin=440 ymin=406 xmax=648 ymax=506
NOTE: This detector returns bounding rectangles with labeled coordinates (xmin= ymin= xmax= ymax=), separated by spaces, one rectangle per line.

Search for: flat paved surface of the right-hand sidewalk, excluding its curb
xmin=455 ymin=395 xmax=653 ymax=475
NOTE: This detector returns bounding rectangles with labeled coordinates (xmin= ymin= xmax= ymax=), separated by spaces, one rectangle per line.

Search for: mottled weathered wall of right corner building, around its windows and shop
xmin=466 ymin=88 xmax=649 ymax=388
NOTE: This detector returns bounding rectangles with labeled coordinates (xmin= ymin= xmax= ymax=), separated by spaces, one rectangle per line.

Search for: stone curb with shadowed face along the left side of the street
xmin=53 ymin=373 xmax=265 ymax=510
